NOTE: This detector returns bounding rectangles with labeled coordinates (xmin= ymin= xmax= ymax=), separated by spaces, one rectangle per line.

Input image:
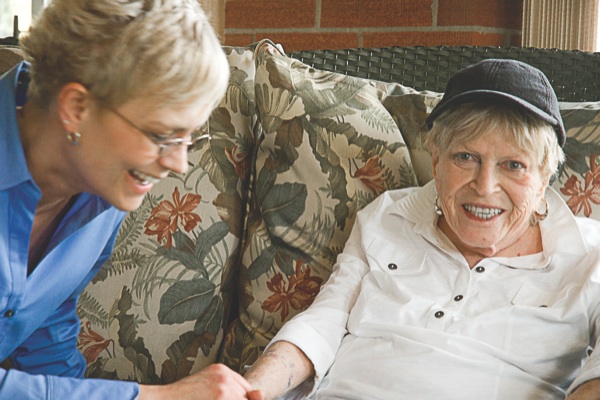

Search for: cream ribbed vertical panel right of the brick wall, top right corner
xmin=522 ymin=0 xmax=599 ymax=51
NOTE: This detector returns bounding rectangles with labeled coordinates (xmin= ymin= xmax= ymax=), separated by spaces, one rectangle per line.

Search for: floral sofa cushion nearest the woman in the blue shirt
xmin=78 ymin=43 xmax=256 ymax=383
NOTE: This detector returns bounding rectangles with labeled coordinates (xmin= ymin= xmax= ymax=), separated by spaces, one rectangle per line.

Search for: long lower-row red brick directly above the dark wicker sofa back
xmin=363 ymin=31 xmax=506 ymax=47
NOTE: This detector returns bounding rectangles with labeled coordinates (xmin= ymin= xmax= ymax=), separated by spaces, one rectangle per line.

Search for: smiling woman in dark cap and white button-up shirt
xmin=245 ymin=60 xmax=600 ymax=400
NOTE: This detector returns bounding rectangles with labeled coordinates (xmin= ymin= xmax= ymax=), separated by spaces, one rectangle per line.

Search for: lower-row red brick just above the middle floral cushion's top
xmin=256 ymin=33 xmax=358 ymax=53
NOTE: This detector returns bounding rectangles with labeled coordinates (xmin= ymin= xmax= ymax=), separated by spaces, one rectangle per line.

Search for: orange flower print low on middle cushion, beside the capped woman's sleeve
xmin=262 ymin=260 xmax=323 ymax=320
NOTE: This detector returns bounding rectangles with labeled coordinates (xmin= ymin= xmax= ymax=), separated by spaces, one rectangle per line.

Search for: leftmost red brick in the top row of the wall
xmin=225 ymin=0 xmax=317 ymax=29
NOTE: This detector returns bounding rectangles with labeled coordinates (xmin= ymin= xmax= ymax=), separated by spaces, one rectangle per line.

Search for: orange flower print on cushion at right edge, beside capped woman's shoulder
xmin=560 ymin=155 xmax=600 ymax=217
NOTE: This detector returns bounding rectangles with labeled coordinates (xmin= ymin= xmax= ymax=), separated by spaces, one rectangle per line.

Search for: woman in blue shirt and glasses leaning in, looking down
xmin=0 ymin=0 xmax=262 ymax=400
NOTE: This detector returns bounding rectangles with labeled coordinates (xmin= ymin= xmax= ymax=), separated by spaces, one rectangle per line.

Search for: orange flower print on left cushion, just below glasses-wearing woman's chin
xmin=144 ymin=187 xmax=202 ymax=247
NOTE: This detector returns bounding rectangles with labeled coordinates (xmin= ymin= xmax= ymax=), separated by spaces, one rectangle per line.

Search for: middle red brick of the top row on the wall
xmin=321 ymin=0 xmax=433 ymax=28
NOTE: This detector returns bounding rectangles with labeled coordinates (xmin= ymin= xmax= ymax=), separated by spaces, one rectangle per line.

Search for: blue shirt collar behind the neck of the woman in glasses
xmin=0 ymin=62 xmax=32 ymax=190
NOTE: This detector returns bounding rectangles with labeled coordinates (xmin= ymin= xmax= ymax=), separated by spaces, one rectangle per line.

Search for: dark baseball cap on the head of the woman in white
xmin=427 ymin=59 xmax=566 ymax=147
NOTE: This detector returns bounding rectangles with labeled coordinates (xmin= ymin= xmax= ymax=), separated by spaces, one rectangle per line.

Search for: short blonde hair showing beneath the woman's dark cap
xmin=427 ymin=103 xmax=565 ymax=178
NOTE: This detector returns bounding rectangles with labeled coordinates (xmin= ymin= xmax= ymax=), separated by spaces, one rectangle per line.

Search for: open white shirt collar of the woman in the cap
xmin=387 ymin=180 xmax=588 ymax=269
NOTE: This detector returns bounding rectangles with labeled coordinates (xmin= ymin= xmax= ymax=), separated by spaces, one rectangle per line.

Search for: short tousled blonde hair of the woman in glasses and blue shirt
xmin=20 ymin=0 xmax=229 ymax=107
